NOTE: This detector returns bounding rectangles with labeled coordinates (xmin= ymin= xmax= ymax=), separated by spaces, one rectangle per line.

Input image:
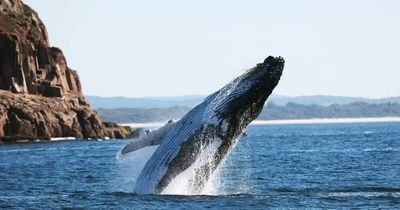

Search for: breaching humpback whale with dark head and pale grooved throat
xmin=122 ymin=56 xmax=284 ymax=194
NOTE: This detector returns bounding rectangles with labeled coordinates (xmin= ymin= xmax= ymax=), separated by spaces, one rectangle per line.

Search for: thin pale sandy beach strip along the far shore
xmin=120 ymin=117 xmax=400 ymax=128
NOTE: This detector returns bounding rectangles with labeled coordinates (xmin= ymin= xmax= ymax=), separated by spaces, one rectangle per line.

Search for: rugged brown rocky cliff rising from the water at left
xmin=0 ymin=0 xmax=131 ymax=141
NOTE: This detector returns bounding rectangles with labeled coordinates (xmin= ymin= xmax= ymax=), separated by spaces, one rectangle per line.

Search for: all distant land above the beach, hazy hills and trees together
xmin=86 ymin=95 xmax=400 ymax=123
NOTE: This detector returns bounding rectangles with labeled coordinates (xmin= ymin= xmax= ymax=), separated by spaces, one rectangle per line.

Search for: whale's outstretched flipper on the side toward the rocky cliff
xmin=120 ymin=120 xmax=175 ymax=155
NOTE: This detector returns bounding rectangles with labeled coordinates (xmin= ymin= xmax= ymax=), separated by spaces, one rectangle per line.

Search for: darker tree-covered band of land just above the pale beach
xmin=98 ymin=102 xmax=400 ymax=123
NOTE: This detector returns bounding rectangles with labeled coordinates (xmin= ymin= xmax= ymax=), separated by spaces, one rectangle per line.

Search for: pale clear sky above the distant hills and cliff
xmin=24 ymin=0 xmax=400 ymax=98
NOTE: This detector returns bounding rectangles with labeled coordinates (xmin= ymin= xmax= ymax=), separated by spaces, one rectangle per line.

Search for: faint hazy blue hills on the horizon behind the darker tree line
xmin=86 ymin=95 xmax=400 ymax=109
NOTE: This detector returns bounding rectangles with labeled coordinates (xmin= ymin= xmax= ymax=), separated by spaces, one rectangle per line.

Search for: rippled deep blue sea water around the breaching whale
xmin=0 ymin=123 xmax=400 ymax=209
